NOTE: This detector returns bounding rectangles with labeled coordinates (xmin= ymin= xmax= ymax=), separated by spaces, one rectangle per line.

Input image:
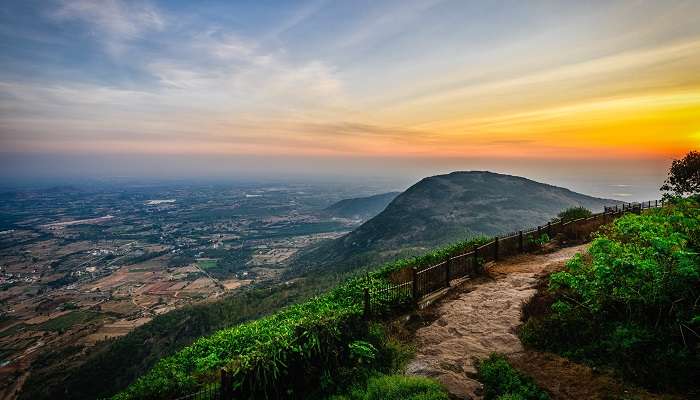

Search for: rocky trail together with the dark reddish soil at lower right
xmin=407 ymin=245 xmax=672 ymax=399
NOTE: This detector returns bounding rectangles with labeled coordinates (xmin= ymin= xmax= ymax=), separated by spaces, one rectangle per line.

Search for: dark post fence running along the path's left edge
xmin=363 ymin=200 xmax=663 ymax=318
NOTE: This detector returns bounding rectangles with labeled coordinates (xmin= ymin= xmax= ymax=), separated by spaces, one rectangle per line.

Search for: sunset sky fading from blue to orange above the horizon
xmin=0 ymin=0 xmax=700 ymax=197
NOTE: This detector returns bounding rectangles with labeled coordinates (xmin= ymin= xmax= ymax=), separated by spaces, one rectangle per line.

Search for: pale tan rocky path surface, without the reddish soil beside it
xmin=407 ymin=245 xmax=586 ymax=399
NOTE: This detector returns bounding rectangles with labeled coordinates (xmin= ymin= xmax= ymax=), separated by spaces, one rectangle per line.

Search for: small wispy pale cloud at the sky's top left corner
xmin=50 ymin=0 xmax=165 ymax=55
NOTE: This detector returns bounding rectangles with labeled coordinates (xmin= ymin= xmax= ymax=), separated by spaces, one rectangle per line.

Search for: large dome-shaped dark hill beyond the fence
xmin=293 ymin=171 xmax=615 ymax=270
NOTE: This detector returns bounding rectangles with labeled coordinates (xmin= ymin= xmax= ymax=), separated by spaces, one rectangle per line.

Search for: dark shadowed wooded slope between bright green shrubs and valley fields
xmin=20 ymin=276 xmax=339 ymax=399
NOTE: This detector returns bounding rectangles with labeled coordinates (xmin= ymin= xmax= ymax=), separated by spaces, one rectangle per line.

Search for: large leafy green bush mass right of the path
xmin=521 ymin=198 xmax=700 ymax=388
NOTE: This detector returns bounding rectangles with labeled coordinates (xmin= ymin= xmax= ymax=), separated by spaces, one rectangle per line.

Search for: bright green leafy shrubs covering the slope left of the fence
xmin=115 ymin=274 xmax=410 ymax=399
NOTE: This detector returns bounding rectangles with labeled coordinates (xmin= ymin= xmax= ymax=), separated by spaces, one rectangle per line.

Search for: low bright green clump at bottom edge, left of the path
xmin=330 ymin=375 xmax=449 ymax=400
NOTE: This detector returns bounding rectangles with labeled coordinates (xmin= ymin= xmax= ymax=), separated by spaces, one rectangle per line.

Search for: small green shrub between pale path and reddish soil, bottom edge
xmin=476 ymin=353 xmax=549 ymax=400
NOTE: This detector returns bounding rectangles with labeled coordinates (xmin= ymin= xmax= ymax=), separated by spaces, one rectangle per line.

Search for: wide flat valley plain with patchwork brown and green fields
xmin=0 ymin=184 xmax=388 ymax=399
